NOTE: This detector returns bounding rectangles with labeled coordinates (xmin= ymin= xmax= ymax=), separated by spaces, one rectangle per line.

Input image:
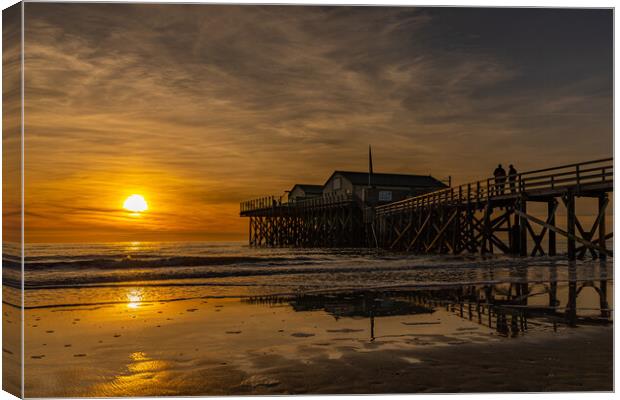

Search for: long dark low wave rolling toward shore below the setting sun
xmin=4 ymin=257 xmax=576 ymax=290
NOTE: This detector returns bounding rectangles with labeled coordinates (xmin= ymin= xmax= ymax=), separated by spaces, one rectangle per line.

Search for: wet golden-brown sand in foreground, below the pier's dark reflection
xmin=17 ymin=290 xmax=613 ymax=397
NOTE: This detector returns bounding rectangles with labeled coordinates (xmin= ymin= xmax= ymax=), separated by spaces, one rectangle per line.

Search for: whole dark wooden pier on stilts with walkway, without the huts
xmin=241 ymin=158 xmax=613 ymax=260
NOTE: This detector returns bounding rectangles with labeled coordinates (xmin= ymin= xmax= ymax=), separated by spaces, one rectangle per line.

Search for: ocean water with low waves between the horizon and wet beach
xmin=4 ymin=242 xmax=613 ymax=308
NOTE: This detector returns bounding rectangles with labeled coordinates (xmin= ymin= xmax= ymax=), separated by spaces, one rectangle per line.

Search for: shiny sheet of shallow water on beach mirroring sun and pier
xmin=13 ymin=272 xmax=613 ymax=397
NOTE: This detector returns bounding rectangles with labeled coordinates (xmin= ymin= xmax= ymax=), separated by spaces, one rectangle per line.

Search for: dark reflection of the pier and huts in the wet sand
xmin=248 ymin=262 xmax=612 ymax=340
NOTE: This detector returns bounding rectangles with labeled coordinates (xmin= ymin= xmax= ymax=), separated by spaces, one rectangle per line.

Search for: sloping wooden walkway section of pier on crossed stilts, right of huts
xmin=373 ymin=158 xmax=613 ymax=260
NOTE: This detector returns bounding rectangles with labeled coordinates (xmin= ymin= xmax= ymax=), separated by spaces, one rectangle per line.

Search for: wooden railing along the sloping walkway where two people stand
xmin=376 ymin=158 xmax=614 ymax=215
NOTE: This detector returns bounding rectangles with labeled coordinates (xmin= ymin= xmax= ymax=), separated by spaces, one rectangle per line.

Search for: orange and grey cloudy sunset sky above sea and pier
xmin=25 ymin=3 xmax=613 ymax=242
